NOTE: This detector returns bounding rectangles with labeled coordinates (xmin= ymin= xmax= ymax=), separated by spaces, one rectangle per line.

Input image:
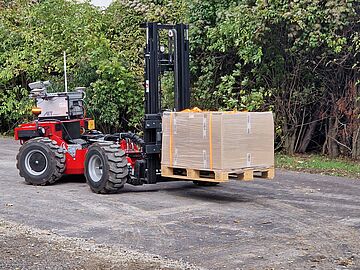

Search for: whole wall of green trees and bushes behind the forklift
xmin=0 ymin=0 xmax=360 ymax=159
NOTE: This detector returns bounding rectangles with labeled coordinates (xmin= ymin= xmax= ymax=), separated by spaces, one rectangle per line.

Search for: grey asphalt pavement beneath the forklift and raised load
xmin=0 ymin=138 xmax=360 ymax=269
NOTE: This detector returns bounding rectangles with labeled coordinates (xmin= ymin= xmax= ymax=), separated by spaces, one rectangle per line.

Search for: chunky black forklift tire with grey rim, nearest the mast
xmin=85 ymin=142 xmax=129 ymax=194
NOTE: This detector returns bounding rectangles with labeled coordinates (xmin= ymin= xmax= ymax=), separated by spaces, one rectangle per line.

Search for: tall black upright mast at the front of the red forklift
xmin=142 ymin=23 xmax=190 ymax=184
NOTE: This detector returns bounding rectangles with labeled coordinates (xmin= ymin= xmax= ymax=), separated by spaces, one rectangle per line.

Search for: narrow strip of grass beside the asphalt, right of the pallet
xmin=275 ymin=154 xmax=360 ymax=179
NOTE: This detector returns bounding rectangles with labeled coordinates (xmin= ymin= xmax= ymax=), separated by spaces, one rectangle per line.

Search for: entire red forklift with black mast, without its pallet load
xmin=15 ymin=23 xmax=207 ymax=193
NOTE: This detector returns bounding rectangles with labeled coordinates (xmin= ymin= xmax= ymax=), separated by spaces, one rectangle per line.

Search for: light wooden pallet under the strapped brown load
xmin=161 ymin=165 xmax=275 ymax=182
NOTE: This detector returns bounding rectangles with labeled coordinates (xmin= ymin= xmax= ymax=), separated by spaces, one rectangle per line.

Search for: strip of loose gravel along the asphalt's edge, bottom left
xmin=0 ymin=221 xmax=200 ymax=270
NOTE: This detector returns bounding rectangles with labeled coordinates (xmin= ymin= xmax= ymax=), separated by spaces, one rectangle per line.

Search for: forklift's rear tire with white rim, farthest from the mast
xmin=16 ymin=137 xmax=65 ymax=185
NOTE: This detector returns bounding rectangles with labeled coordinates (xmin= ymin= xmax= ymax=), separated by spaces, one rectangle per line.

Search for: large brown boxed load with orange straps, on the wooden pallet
xmin=161 ymin=112 xmax=274 ymax=170
